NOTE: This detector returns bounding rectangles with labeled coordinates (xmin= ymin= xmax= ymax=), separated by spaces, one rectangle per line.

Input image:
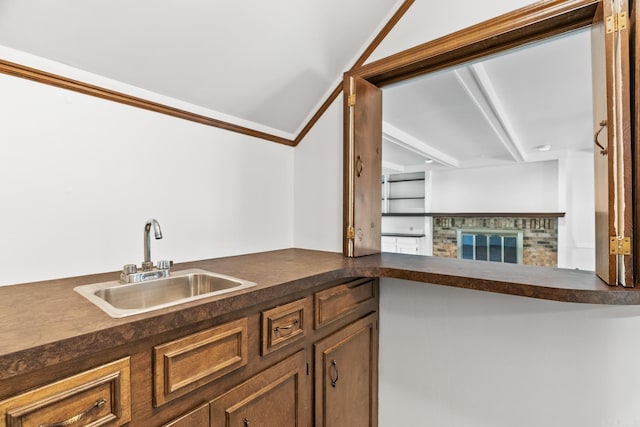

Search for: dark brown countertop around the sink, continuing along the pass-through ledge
xmin=0 ymin=249 xmax=640 ymax=380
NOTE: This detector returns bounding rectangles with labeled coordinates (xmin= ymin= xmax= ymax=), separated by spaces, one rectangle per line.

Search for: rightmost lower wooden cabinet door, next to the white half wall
xmin=314 ymin=313 xmax=378 ymax=427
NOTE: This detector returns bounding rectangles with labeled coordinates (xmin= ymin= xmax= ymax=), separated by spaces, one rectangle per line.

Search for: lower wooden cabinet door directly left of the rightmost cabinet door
xmin=210 ymin=351 xmax=309 ymax=427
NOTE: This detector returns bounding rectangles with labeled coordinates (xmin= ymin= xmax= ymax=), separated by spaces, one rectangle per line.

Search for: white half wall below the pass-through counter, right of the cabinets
xmin=380 ymin=279 xmax=640 ymax=427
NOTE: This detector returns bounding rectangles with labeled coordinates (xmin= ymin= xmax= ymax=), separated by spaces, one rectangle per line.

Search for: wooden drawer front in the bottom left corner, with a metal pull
xmin=0 ymin=357 xmax=131 ymax=427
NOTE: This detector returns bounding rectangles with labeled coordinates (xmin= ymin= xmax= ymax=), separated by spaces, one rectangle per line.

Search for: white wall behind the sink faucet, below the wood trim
xmin=0 ymin=69 xmax=293 ymax=284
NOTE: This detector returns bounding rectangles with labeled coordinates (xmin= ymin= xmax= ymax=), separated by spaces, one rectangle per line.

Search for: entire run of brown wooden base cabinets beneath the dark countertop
xmin=0 ymin=278 xmax=378 ymax=427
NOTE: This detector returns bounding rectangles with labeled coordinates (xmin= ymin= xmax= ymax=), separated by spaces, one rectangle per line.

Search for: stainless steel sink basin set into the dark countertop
xmin=74 ymin=269 xmax=255 ymax=318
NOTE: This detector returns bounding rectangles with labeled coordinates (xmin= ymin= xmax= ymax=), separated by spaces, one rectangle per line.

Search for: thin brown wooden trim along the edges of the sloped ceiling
xmin=0 ymin=0 xmax=415 ymax=147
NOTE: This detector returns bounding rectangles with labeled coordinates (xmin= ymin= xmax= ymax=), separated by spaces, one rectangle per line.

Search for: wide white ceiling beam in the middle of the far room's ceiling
xmin=453 ymin=64 xmax=527 ymax=162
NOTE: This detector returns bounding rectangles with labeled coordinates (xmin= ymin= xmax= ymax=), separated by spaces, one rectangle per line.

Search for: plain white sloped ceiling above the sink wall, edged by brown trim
xmin=0 ymin=0 xmax=402 ymax=136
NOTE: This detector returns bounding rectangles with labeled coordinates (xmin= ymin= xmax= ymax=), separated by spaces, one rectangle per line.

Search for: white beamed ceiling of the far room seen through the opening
xmin=383 ymin=30 xmax=593 ymax=172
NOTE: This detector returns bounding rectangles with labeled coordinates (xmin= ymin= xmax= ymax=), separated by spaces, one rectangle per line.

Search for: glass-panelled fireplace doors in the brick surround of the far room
xmin=457 ymin=230 xmax=523 ymax=264
